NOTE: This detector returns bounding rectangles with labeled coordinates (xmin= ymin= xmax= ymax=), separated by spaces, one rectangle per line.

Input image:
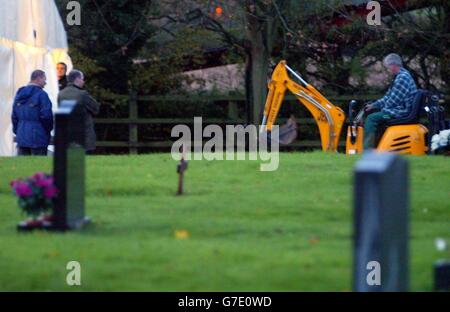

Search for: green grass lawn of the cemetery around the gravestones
xmin=0 ymin=152 xmax=450 ymax=291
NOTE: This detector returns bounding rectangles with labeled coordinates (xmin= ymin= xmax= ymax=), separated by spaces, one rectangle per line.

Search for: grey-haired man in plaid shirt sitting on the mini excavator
xmin=364 ymin=53 xmax=417 ymax=150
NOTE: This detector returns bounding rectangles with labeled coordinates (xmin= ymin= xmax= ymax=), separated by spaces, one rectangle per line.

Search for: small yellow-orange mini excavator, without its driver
xmin=262 ymin=61 xmax=428 ymax=155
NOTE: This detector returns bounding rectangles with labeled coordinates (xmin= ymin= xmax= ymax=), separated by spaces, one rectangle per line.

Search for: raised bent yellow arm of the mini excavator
xmin=262 ymin=61 xmax=345 ymax=151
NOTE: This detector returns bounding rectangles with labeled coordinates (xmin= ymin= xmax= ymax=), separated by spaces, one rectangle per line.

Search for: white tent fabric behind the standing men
xmin=0 ymin=0 xmax=72 ymax=156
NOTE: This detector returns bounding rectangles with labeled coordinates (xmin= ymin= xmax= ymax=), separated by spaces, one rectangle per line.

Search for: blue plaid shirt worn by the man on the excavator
xmin=373 ymin=68 xmax=417 ymax=118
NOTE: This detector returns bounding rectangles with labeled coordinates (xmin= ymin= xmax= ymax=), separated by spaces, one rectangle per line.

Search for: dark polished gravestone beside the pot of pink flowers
xmin=53 ymin=101 xmax=89 ymax=231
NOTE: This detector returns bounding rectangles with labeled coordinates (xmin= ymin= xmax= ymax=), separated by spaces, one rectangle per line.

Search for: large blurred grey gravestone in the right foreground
xmin=353 ymin=152 xmax=409 ymax=292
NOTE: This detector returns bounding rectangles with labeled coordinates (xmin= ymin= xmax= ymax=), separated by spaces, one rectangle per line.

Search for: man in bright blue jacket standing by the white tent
xmin=12 ymin=70 xmax=53 ymax=156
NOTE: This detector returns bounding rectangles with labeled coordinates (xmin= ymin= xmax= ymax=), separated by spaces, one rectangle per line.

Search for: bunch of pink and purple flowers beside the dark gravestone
xmin=10 ymin=172 xmax=58 ymax=220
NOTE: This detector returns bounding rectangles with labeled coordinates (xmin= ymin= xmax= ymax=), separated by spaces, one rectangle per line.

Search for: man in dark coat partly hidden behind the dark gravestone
xmin=58 ymin=70 xmax=100 ymax=154
